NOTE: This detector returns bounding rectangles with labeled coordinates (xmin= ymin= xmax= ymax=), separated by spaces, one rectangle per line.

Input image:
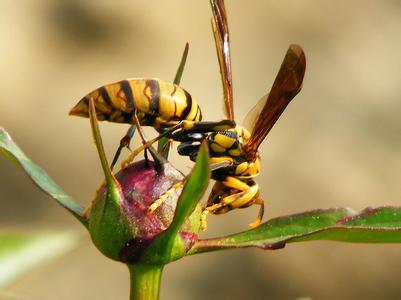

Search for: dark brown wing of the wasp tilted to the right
xmin=244 ymin=44 xmax=306 ymax=160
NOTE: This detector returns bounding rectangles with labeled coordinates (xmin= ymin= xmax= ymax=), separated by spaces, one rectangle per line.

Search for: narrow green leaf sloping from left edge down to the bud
xmin=0 ymin=127 xmax=86 ymax=225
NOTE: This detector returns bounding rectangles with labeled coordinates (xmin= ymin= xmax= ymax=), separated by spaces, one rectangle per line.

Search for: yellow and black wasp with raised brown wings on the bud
xmin=70 ymin=0 xmax=306 ymax=227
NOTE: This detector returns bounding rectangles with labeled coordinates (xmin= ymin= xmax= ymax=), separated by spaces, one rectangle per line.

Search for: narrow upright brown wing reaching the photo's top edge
xmin=210 ymin=0 xmax=234 ymax=120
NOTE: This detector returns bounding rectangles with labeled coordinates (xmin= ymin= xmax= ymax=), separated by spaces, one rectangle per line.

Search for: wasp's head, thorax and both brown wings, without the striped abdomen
xmin=173 ymin=0 xmax=306 ymax=227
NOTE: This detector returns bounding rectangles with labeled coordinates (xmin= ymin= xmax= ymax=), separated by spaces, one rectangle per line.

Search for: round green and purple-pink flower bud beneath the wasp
xmin=87 ymin=160 xmax=200 ymax=264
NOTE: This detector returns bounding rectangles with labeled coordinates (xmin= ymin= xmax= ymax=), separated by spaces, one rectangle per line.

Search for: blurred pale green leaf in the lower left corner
xmin=0 ymin=231 xmax=78 ymax=288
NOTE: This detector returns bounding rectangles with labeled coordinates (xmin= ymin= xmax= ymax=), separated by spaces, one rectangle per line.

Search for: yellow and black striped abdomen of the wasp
xmin=70 ymin=78 xmax=202 ymax=128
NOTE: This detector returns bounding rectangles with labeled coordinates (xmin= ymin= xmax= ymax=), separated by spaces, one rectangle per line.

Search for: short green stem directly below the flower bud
xmin=128 ymin=264 xmax=164 ymax=300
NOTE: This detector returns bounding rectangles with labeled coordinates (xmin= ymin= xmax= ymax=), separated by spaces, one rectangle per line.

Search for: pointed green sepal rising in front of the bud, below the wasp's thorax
xmin=145 ymin=143 xmax=210 ymax=261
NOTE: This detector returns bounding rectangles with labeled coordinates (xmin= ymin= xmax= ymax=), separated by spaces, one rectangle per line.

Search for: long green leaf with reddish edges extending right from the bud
xmin=190 ymin=207 xmax=401 ymax=254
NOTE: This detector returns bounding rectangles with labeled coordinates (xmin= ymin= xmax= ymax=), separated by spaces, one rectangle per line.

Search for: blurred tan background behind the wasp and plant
xmin=0 ymin=0 xmax=401 ymax=300
